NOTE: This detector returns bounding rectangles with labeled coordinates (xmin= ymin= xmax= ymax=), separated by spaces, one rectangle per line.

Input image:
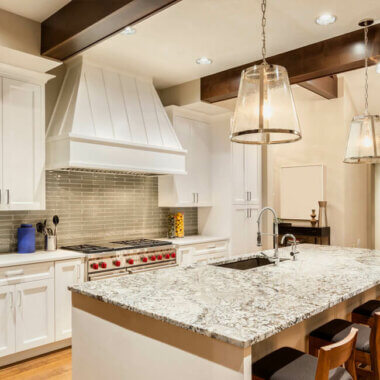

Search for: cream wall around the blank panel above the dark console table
xmin=266 ymin=80 xmax=369 ymax=247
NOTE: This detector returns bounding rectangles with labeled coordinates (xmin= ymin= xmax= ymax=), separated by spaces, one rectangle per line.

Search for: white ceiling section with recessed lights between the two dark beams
xmin=82 ymin=0 xmax=380 ymax=88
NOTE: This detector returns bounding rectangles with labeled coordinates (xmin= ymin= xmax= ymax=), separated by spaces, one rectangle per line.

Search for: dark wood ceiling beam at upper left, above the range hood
xmin=41 ymin=0 xmax=180 ymax=60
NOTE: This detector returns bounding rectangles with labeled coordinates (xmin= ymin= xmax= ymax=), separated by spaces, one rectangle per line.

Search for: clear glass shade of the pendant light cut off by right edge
xmin=344 ymin=115 xmax=380 ymax=164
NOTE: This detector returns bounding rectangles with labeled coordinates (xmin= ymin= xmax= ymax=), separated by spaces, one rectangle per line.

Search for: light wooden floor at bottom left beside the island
xmin=0 ymin=348 xmax=71 ymax=380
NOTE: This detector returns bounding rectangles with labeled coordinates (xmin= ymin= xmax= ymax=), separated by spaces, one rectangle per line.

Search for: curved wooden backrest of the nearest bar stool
xmin=315 ymin=328 xmax=358 ymax=380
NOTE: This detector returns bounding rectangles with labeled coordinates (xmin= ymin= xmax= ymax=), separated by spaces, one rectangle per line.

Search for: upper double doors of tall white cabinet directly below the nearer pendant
xmin=231 ymin=143 xmax=261 ymax=205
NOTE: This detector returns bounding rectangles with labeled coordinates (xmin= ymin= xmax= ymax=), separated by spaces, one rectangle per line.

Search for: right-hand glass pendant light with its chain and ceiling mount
xmin=344 ymin=19 xmax=380 ymax=164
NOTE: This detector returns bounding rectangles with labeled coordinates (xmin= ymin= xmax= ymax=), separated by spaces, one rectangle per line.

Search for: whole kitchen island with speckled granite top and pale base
xmin=71 ymin=245 xmax=380 ymax=380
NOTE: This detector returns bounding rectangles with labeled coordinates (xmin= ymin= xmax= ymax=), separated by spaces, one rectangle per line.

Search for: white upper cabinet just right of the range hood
xmin=158 ymin=110 xmax=212 ymax=207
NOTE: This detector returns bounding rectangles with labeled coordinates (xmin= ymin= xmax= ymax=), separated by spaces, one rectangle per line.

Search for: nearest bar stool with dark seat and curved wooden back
xmin=252 ymin=328 xmax=358 ymax=380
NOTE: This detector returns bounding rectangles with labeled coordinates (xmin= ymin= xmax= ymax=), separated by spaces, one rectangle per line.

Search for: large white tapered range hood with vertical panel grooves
xmin=46 ymin=57 xmax=186 ymax=175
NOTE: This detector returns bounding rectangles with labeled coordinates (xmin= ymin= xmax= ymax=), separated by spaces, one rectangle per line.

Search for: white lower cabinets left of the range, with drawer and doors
xmin=0 ymin=259 xmax=84 ymax=357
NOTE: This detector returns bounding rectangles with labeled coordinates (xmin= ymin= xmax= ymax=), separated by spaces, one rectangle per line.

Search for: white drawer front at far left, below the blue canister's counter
xmin=0 ymin=262 xmax=54 ymax=285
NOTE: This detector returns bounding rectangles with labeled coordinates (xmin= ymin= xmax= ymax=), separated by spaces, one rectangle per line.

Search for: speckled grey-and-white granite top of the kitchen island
xmin=71 ymin=245 xmax=380 ymax=347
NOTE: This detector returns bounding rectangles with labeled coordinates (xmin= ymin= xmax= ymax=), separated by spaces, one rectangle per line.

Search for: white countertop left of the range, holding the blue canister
xmin=0 ymin=249 xmax=85 ymax=268
